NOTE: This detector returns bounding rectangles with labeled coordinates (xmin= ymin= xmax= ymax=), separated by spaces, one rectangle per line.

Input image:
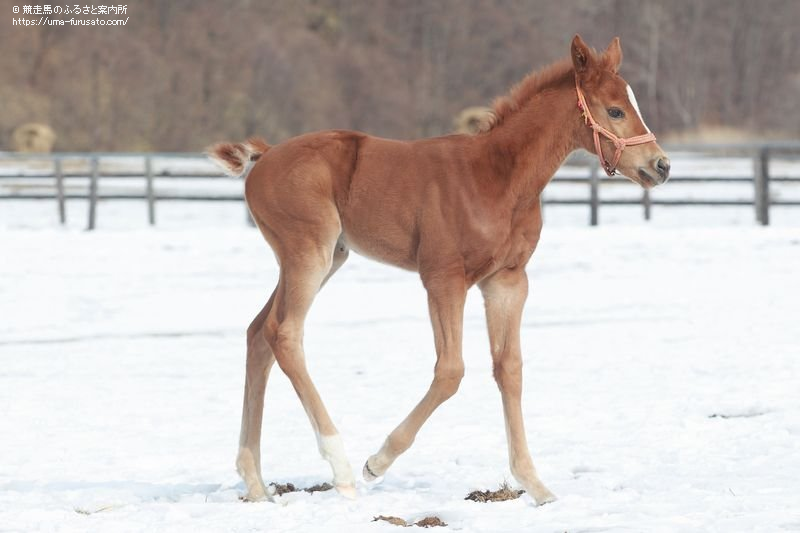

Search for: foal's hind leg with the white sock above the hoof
xmin=266 ymin=242 xmax=355 ymax=497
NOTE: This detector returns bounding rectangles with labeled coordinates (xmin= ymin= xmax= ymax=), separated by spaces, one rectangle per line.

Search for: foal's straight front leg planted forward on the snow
xmin=480 ymin=268 xmax=556 ymax=505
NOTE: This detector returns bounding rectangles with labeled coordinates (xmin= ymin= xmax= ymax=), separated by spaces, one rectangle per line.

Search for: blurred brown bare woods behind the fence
xmin=0 ymin=0 xmax=800 ymax=151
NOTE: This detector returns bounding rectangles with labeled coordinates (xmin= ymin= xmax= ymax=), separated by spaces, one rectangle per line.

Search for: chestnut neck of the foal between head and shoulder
xmin=487 ymin=78 xmax=582 ymax=197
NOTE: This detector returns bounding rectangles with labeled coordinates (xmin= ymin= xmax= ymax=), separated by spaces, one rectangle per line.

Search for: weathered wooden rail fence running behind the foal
xmin=0 ymin=141 xmax=800 ymax=230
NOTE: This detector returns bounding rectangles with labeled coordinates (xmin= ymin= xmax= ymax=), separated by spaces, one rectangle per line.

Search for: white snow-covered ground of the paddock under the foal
xmin=0 ymin=185 xmax=800 ymax=533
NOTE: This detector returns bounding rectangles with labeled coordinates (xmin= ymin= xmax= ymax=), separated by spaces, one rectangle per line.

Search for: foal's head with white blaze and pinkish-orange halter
xmin=572 ymin=35 xmax=669 ymax=188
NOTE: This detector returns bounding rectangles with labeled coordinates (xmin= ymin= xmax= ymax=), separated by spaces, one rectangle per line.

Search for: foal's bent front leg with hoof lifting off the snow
xmin=363 ymin=276 xmax=467 ymax=481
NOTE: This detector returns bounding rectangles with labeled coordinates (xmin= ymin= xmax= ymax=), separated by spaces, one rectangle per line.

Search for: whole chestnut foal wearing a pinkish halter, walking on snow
xmin=209 ymin=35 xmax=669 ymax=504
